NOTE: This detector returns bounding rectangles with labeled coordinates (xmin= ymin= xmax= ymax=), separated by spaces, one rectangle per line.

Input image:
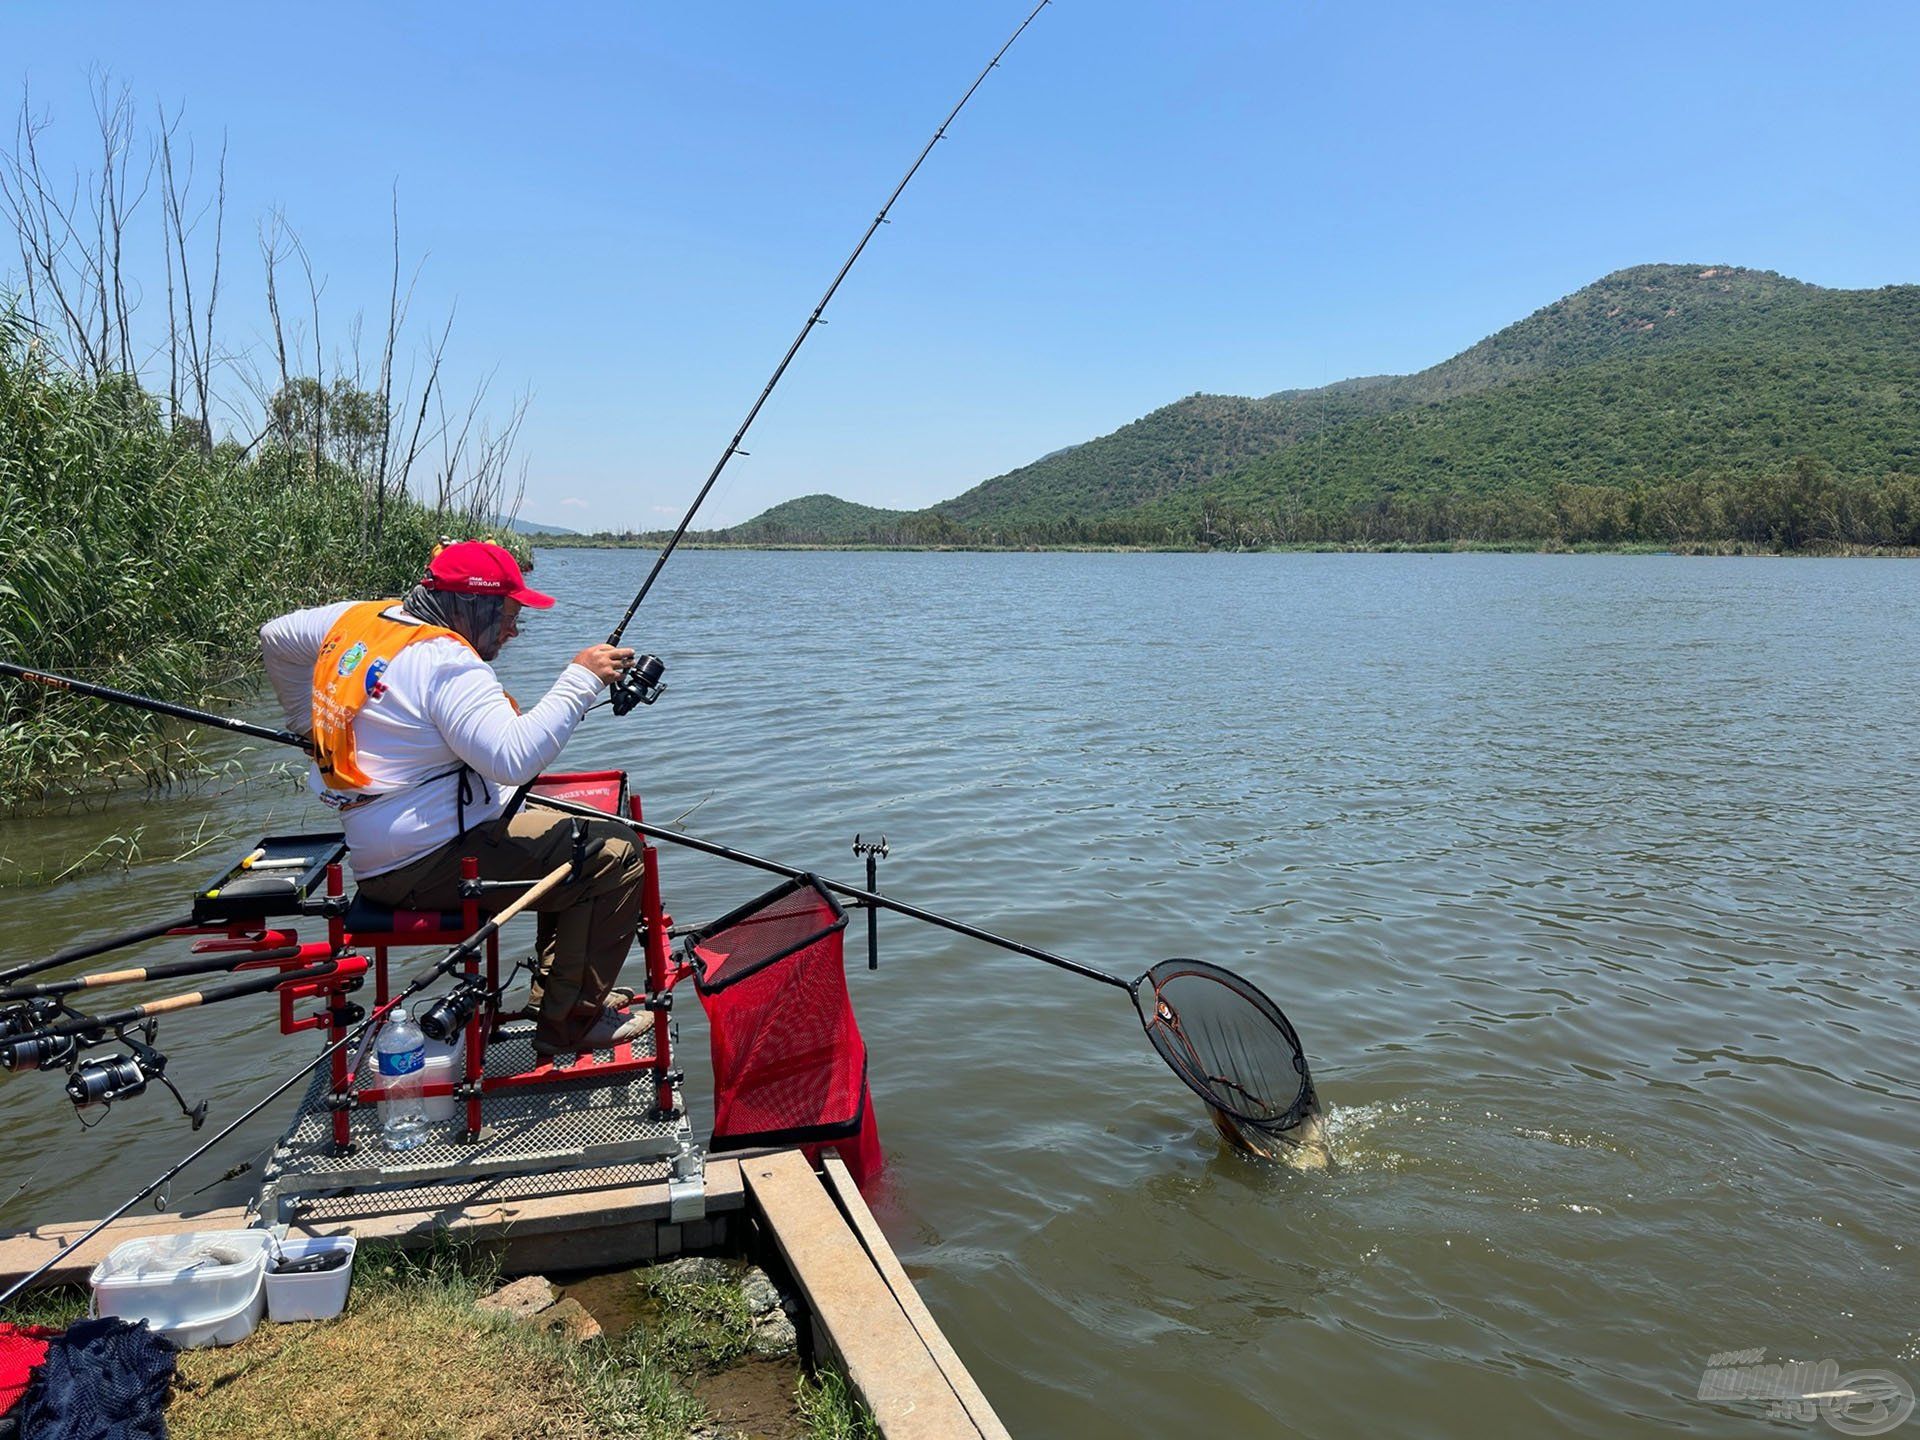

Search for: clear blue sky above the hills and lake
xmin=0 ymin=0 xmax=1920 ymax=528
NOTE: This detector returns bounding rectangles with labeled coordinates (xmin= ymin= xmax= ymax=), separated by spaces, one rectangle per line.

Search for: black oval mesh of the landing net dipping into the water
xmin=1133 ymin=960 xmax=1313 ymax=1131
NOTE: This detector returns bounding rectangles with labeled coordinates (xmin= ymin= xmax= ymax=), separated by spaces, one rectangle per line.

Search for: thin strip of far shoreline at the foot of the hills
xmin=524 ymin=536 xmax=1920 ymax=561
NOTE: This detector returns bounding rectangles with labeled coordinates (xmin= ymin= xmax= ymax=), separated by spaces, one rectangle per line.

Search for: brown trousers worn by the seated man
xmin=361 ymin=810 xmax=643 ymax=1052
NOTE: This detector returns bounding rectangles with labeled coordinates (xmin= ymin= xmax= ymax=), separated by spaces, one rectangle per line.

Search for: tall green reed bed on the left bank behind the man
xmin=0 ymin=309 xmax=503 ymax=808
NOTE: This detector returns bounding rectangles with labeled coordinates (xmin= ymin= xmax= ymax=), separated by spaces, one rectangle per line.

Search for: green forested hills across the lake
xmin=714 ymin=265 xmax=1920 ymax=547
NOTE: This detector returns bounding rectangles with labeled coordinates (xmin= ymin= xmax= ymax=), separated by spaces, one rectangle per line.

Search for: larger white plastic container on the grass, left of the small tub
xmin=86 ymin=1231 xmax=273 ymax=1350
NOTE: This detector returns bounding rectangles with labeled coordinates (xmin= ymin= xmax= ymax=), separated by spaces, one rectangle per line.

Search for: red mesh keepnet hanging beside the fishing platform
xmin=689 ymin=879 xmax=881 ymax=1183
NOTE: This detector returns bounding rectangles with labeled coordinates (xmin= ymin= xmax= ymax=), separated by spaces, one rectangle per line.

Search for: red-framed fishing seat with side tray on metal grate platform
xmin=176 ymin=770 xmax=705 ymax=1225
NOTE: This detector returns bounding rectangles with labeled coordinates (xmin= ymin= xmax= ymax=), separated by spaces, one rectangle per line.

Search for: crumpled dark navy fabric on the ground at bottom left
xmin=13 ymin=1317 xmax=180 ymax=1440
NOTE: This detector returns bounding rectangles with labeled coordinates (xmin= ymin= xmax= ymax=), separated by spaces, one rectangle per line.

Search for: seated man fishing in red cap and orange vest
xmin=259 ymin=540 xmax=651 ymax=1058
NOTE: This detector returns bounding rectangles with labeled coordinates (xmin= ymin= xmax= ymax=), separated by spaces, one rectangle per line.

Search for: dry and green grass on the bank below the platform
xmin=4 ymin=1240 xmax=877 ymax=1440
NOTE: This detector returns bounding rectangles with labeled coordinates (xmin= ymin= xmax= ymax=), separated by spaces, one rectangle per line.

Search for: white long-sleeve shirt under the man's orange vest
xmin=259 ymin=601 xmax=601 ymax=879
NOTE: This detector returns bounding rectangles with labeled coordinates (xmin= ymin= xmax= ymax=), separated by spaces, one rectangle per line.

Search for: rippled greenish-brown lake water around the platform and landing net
xmin=0 ymin=551 xmax=1920 ymax=1436
